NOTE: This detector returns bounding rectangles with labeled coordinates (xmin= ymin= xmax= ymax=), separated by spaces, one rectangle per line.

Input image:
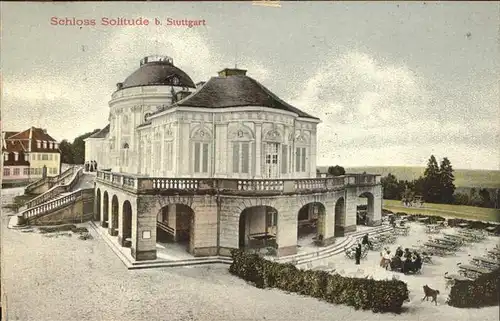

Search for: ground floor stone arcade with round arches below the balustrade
xmin=94 ymin=186 xmax=382 ymax=260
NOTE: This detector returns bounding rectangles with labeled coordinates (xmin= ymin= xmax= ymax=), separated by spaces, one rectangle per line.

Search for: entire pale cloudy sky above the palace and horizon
xmin=0 ymin=2 xmax=500 ymax=170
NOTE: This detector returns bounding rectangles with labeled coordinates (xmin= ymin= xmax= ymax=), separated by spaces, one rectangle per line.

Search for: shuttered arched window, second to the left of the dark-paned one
xmin=191 ymin=126 xmax=212 ymax=174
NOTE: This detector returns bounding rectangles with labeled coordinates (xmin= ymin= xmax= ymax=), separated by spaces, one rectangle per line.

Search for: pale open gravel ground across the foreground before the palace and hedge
xmin=2 ymin=188 xmax=498 ymax=321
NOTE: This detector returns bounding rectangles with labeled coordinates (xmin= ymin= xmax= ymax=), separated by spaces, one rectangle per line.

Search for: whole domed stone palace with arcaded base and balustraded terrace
xmin=85 ymin=56 xmax=382 ymax=260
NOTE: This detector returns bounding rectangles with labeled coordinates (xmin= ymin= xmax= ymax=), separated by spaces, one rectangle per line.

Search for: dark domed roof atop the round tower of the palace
xmin=117 ymin=56 xmax=196 ymax=90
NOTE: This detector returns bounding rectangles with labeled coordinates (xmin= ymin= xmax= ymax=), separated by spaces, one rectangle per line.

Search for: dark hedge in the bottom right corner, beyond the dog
xmin=447 ymin=268 xmax=500 ymax=308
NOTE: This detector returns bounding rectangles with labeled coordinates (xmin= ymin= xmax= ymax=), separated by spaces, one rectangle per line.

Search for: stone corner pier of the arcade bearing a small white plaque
xmin=131 ymin=196 xmax=157 ymax=261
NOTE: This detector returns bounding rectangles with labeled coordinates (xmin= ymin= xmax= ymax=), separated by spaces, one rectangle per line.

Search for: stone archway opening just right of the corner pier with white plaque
xmin=156 ymin=203 xmax=195 ymax=254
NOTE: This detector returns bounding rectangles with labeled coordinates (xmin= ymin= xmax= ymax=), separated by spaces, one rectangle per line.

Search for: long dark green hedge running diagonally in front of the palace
xmin=229 ymin=249 xmax=409 ymax=313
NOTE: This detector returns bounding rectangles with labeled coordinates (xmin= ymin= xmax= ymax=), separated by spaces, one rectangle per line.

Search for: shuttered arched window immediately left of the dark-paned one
xmin=229 ymin=125 xmax=254 ymax=174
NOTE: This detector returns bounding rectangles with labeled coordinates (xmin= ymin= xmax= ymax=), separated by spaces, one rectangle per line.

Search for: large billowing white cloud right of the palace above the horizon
xmin=291 ymin=52 xmax=499 ymax=168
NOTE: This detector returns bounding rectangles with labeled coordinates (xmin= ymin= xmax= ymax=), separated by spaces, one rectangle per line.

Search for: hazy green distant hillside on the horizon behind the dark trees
xmin=318 ymin=166 xmax=500 ymax=188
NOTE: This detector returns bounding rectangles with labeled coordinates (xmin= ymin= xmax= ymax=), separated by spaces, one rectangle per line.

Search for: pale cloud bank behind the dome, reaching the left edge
xmin=3 ymin=28 xmax=270 ymax=139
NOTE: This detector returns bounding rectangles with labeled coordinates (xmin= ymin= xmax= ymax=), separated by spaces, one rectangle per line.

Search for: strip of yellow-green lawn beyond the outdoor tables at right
xmin=383 ymin=200 xmax=500 ymax=222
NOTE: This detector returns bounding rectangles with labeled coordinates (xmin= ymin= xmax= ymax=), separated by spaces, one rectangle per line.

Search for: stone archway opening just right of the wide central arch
xmin=297 ymin=202 xmax=326 ymax=246
